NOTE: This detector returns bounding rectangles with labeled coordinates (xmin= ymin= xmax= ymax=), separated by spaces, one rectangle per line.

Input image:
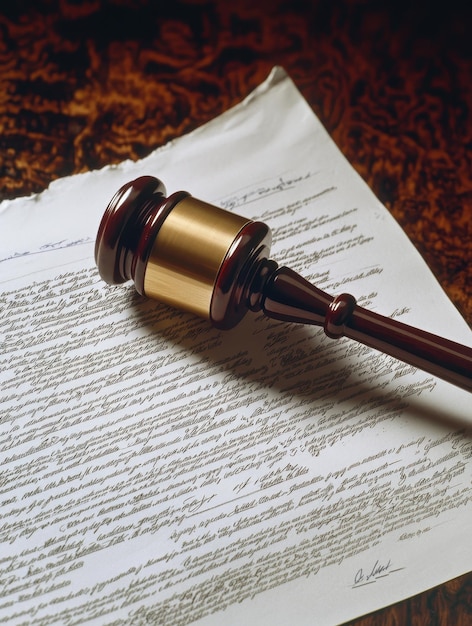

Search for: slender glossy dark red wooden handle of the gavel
xmin=261 ymin=267 xmax=472 ymax=391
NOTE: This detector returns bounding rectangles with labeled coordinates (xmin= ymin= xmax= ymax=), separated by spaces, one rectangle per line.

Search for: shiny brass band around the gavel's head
xmin=144 ymin=196 xmax=251 ymax=318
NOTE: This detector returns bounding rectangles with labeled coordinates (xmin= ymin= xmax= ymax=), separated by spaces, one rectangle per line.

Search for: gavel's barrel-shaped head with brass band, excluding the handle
xmin=95 ymin=176 xmax=277 ymax=329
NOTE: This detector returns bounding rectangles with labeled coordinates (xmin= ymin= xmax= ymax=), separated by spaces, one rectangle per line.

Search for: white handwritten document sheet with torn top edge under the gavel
xmin=0 ymin=68 xmax=472 ymax=626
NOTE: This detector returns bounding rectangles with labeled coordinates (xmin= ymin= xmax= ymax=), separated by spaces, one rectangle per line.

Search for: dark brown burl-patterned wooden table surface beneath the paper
xmin=0 ymin=0 xmax=472 ymax=626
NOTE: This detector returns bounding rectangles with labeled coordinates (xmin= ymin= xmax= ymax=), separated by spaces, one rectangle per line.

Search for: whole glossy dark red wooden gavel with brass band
xmin=95 ymin=176 xmax=472 ymax=391
